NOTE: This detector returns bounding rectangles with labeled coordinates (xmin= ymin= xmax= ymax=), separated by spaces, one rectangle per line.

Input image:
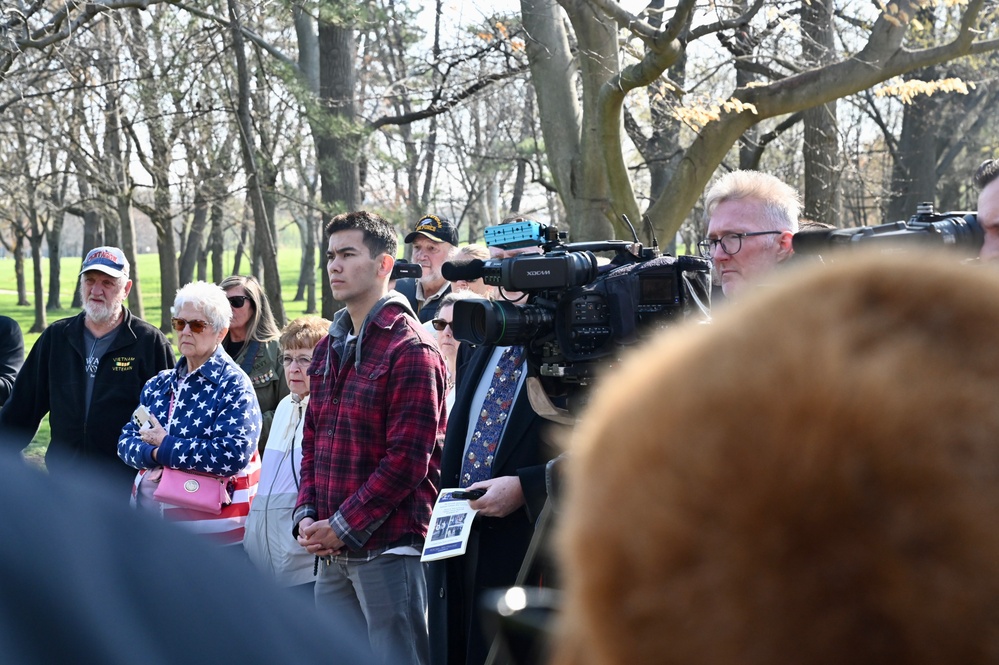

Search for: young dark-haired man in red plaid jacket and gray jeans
xmin=293 ymin=211 xmax=446 ymax=665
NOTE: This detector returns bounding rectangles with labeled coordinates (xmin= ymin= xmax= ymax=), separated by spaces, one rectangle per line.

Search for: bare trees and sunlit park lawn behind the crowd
xmin=0 ymin=0 xmax=999 ymax=456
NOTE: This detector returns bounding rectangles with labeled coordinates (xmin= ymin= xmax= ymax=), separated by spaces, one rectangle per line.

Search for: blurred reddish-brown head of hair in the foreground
xmin=555 ymin=254 xmax=999 ymax=665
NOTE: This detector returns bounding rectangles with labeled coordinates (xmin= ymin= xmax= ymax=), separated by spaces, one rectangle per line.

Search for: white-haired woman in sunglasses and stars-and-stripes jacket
xmin=118 ymin=282 xmax=261 ymax=545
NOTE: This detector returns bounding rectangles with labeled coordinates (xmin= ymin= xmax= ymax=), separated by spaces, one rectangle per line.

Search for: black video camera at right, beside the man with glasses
xmin=792 ymin=203 xmax=983 ymax=257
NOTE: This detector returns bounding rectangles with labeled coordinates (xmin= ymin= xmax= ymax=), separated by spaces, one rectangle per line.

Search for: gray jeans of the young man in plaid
xmin=316 ymin=554 xmax=430 ymax=665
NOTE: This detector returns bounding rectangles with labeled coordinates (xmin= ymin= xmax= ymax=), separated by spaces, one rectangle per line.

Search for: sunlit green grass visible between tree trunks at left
xmin=0 ymin=246 xmax=322 ymax=465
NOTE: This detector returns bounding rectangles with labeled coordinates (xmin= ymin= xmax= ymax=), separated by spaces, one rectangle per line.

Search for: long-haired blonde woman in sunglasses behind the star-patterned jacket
xmin=219 ymin=275 xmax=288 ymax=455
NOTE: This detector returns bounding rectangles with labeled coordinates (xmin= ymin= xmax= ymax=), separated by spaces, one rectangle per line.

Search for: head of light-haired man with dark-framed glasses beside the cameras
xmin=698 ymin=171 xmax=801 ymax=297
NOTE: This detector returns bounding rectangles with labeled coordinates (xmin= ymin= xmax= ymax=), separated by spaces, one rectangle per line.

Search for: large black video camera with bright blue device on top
xmin=441 ymin=221 xmax=711 ymax=422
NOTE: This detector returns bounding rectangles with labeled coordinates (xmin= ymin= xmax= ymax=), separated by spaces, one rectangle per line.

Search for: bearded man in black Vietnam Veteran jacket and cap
xmin=0 ymin=247 xmax=174 ymax=492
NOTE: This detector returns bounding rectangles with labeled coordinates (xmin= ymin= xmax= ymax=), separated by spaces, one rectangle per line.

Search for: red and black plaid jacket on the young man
xmin=294 ymin=303 xmax=447 ymax=557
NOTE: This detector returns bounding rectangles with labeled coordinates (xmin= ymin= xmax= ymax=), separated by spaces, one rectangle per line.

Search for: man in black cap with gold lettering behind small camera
xmin=395 ymin=215 xmax=458 ymax=323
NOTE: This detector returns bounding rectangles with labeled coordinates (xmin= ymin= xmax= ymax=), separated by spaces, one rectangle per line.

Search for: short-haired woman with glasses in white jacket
xmin=243 ymin=316 xmax=330 ymax=597
